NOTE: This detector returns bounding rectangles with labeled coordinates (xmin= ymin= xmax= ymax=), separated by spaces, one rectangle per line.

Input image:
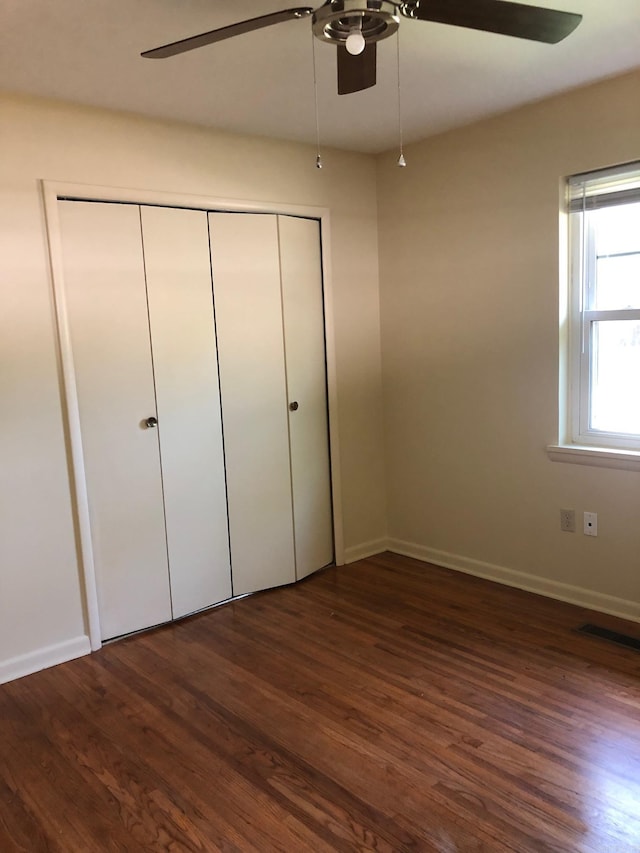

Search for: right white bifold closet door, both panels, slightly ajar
xmin=209 ymin=213 xmax=333 ymax=595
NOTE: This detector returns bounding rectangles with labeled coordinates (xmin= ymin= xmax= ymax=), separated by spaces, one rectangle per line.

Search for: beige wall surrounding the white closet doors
xmin=0 ymin=96 xmax=386 ymax=680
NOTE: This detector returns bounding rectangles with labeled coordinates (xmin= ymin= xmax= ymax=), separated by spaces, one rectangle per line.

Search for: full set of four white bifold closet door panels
xmin=58 ymin=199 xmax=333 ymax=639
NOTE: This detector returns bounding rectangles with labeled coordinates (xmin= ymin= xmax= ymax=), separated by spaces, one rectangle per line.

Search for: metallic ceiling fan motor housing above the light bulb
xmin=313 ymin=0 xmax=400 ymax=45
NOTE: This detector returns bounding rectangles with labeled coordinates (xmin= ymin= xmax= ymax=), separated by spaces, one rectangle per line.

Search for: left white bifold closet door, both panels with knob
xmin=59 ymin=201 xmax=231 ymax=639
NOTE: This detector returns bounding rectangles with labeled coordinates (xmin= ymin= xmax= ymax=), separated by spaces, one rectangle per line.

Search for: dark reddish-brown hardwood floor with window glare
xmin=0 ymin=554 xmax=640 ymax=853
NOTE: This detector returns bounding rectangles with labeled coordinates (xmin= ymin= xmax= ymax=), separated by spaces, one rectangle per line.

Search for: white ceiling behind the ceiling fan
xmin=0 ymin=0 xmax=640 ymax=152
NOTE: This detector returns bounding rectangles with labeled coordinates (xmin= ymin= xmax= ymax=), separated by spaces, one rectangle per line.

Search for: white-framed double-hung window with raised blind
xmin=569 ymin=163 xmax=640 ymax=451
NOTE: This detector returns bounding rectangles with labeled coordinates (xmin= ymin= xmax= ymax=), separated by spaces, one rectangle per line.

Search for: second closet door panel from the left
xmin=141 ymin=207 xmax=231 ymax=618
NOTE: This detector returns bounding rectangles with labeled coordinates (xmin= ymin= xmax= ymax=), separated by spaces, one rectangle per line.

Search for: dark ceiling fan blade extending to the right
xmin=400 ymin=0 xmax=582 ymax=44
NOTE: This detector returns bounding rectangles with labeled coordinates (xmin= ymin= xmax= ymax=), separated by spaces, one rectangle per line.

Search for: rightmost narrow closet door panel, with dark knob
xmin=278 ymin=216 xmax=333 ymax=580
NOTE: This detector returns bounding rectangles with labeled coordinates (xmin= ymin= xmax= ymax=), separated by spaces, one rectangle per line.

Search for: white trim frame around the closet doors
xmin=40 ymin=180 xmax=344 ymax=651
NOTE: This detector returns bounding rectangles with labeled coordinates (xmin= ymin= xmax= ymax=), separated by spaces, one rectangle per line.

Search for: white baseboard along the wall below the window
xmin=388 ymin=539 xmax=640 ymax=622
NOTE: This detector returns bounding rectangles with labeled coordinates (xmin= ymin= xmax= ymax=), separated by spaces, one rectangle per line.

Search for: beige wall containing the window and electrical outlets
xmin=378 ymin=66 xmax=640 ymax=619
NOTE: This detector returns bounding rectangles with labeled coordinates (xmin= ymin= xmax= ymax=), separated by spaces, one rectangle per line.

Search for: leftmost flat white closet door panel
xmin=59 ymin=201 xmax=171 ymax=639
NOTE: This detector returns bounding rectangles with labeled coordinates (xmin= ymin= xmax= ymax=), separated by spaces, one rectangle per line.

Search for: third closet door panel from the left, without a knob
xmin=209 ymin=213 xmax=295 ymax=595
